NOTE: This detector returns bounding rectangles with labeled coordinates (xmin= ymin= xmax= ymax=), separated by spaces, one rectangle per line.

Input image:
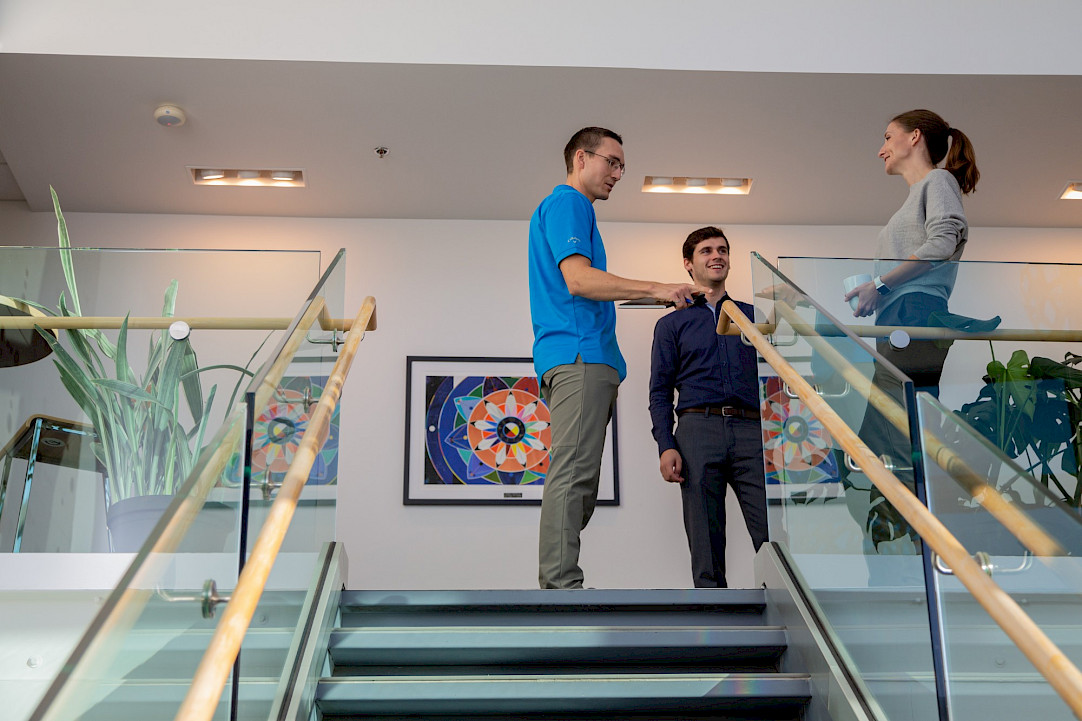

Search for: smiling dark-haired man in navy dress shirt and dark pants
xmin=650 ymin=226 xmax=767 ymax=588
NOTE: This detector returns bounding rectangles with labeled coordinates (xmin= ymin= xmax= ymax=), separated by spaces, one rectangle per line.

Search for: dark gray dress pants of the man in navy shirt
xmin=675 ymin=414 xmax=767 ymax=588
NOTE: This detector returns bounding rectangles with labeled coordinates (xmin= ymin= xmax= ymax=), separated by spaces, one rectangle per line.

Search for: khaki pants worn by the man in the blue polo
xmin=538 ymin=358 xmax=620 ymax=588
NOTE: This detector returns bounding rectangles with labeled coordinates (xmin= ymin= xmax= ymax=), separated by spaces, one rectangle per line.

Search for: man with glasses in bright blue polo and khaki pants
xmin=529 ymin=128 xmax=701 ymax=588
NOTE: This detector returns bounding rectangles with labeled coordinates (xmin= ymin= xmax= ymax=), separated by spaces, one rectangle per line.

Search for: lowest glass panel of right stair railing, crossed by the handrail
xmin=918 ymin=394 xmax=1082 ymax=721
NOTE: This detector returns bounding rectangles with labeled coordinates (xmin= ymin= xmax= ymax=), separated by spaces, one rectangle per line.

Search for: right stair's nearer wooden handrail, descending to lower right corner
xmin=722 ymin=301 xmax=1082 ymax=719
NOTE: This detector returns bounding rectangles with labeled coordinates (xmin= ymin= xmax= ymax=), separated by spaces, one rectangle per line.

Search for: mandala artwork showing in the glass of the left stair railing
xmin=252 ymin=376 xmax=340 ymax=485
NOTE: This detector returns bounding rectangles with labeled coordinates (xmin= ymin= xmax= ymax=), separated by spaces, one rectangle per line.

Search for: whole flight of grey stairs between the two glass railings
xmin=316 ymin=589 xmax=812 ymax=721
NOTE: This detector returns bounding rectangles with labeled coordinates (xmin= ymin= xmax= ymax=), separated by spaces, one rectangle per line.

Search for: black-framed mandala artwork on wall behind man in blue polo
xmin=403 ymin=356 xmax=619 ymax=506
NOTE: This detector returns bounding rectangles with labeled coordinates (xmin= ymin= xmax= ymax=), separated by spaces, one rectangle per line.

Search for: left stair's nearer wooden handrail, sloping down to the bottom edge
xmin=175 ymin=297 xmax=375 ymax=721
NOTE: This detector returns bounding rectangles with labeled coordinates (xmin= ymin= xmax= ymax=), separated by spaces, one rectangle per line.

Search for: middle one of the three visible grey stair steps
xmin=330 ymin=626 xmax=786 ymax=674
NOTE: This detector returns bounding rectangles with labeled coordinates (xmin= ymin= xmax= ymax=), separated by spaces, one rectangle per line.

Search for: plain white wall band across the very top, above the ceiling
xmin=0 ymin=0 xmax=1082 ymax=75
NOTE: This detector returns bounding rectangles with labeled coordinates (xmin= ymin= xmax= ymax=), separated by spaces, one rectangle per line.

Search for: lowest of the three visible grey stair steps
xmin=316 ymin=673 xmax=812 ymax=719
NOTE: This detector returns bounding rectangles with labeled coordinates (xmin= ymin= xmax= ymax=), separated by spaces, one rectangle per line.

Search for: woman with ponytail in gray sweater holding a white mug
xmin=845 ymin=110 xmax=980 ymax=553
